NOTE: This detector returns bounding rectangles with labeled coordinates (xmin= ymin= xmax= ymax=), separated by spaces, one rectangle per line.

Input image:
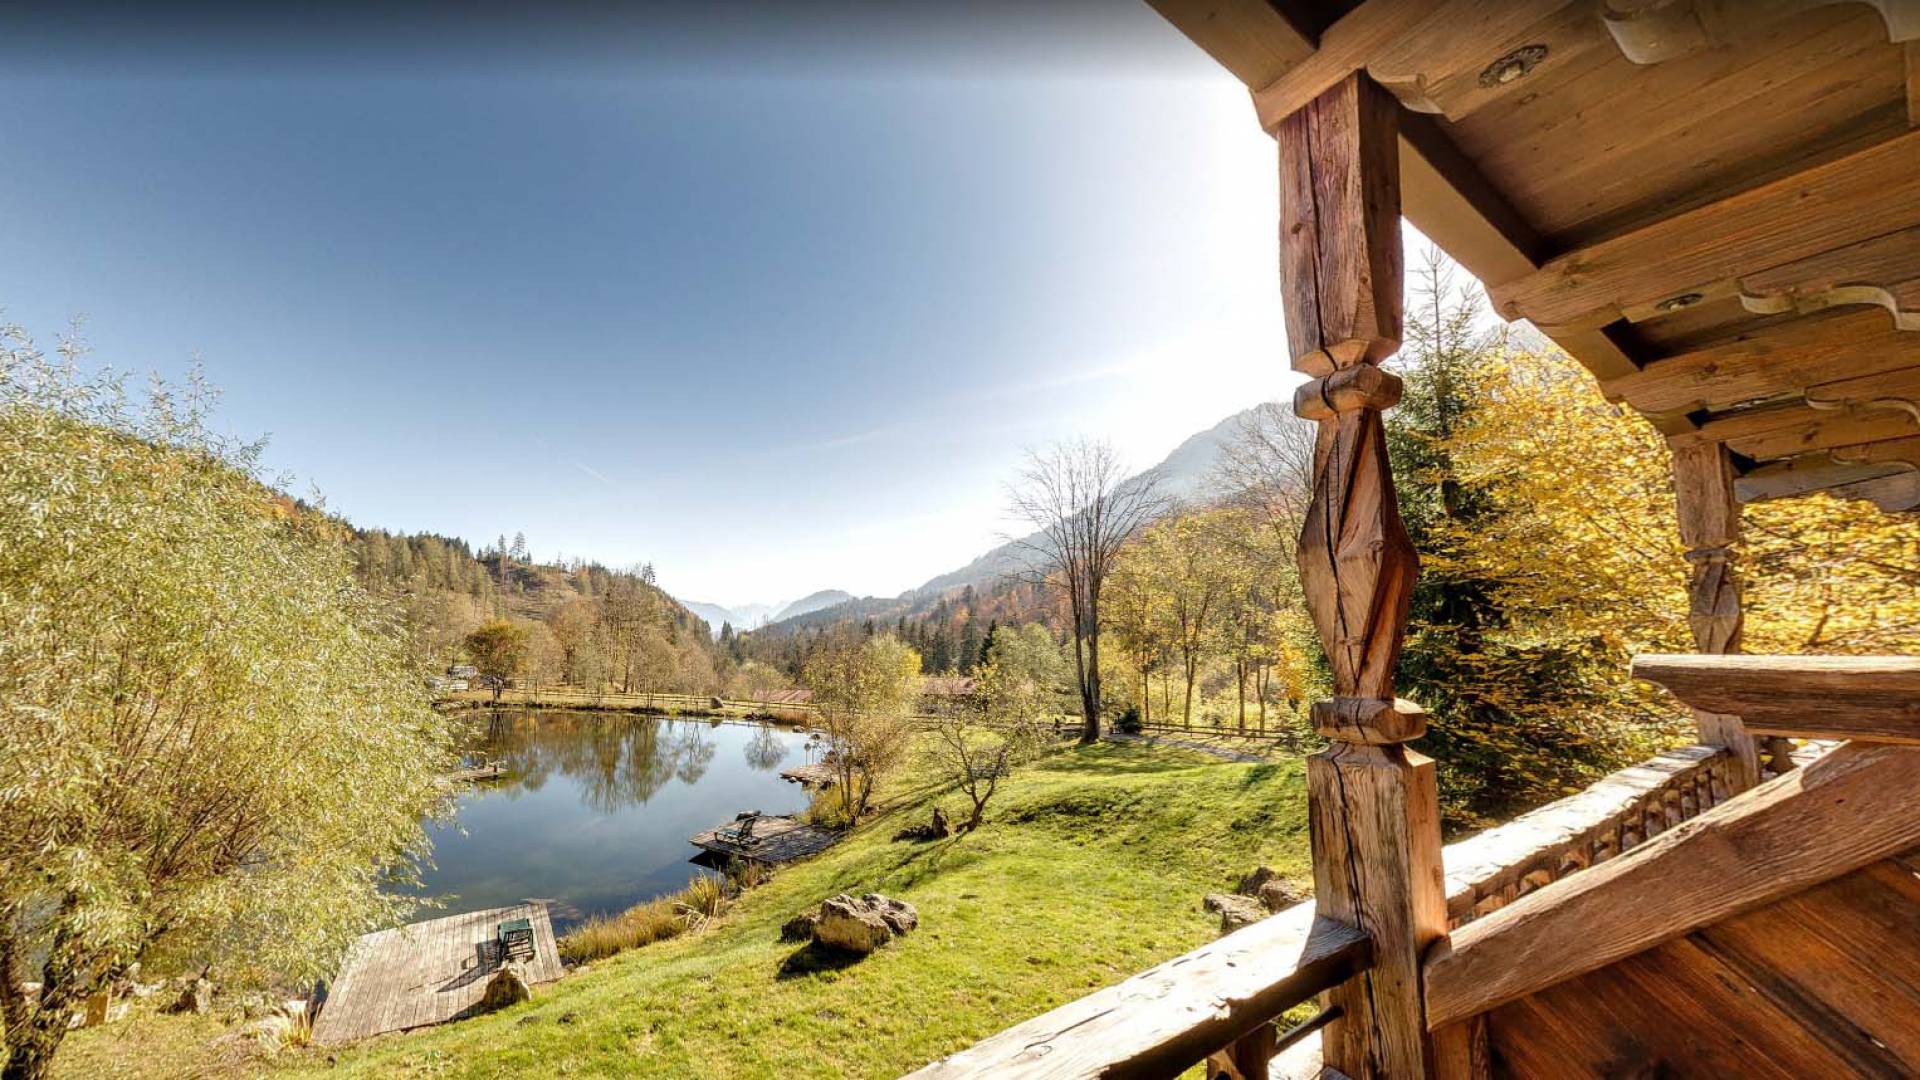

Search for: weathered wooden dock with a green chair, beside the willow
xmin=313 ymin=901 xmax=561 ymax=1045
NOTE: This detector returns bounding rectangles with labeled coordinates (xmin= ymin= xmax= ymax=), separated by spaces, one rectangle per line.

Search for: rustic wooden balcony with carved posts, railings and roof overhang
xmin=925 ymin=0 xmax=1920 ymax=1080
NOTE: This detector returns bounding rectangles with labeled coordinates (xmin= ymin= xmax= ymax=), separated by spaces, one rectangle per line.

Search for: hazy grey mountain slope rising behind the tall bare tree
xmin=748 ymin=405 xmax=1267 ymax=632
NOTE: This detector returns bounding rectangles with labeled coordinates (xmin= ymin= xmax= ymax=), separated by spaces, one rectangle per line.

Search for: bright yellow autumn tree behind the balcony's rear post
xmin=1423 ymin=338 xmax=1920 ymax=814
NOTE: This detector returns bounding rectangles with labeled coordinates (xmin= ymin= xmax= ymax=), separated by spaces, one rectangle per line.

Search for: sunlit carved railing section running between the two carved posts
xmin=1446 ymin=746 xmax=1734 ymax=930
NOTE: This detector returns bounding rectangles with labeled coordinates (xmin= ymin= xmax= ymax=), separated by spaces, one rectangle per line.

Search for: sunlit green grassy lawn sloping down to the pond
xmin=60 ymin=744 xmax=1309 ymax=1076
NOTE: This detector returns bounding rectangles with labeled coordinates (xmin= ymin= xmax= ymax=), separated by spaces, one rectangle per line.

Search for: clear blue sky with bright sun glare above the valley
xmin=0 ymin=0 xmax=1294 ymax=603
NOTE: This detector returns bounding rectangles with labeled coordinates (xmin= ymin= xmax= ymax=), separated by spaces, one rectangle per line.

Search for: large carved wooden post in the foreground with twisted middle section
xmin=1275 ymin=75 xmax=1446 ymax=1080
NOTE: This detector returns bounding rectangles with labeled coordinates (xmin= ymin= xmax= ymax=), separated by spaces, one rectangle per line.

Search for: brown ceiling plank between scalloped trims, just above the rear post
xmin=1601 ymin=309 xmax=1920 ymax=413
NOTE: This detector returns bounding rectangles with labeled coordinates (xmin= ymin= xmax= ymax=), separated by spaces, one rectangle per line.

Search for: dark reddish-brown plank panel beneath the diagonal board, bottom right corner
xmin=1484 ymin=857 xmax=1920 ymax=1078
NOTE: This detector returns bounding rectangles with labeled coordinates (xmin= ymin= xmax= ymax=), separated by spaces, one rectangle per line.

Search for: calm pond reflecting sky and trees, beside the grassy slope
xmin=417 ymin=709 xmax=808 ymax=934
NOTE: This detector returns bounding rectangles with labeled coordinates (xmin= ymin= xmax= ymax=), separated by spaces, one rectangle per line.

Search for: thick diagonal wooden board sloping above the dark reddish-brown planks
xmin=1427 ymin=737 xmax=1920 ymax=1026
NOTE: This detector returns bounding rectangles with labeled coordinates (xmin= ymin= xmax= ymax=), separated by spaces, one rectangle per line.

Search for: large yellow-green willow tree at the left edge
xmin=0 ymin=338 xmax=447 ymax=1080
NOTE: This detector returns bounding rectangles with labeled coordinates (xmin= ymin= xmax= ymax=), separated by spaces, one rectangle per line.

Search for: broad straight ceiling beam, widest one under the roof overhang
xmin=1488 ymin=125 xmax=1920 ymax=327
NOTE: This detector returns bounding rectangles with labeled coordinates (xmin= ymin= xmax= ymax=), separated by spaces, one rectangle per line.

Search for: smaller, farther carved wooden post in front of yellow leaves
xmin=1674 ymin=442 xmax=1761 ymax=794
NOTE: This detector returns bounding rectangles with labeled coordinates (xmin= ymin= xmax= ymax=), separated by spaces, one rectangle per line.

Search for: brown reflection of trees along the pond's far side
xmin=474 ymin=711 xmax=733 ymax=813
